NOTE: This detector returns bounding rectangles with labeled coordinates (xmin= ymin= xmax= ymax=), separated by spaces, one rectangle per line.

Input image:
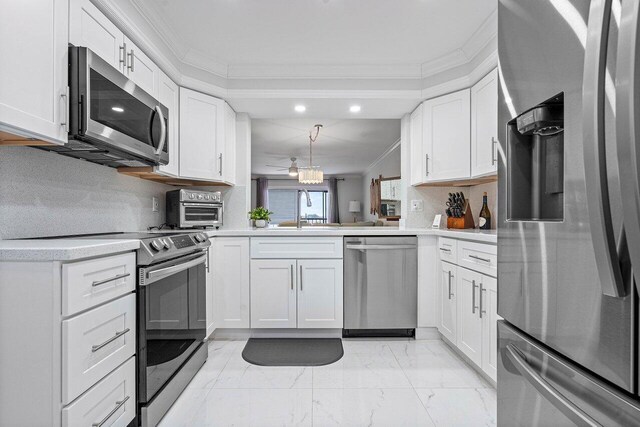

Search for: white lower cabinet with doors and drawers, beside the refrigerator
xmin=438 ymin=238 xmax=500 ymax=381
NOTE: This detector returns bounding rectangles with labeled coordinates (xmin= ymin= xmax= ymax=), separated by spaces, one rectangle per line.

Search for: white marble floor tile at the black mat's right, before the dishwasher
xmin=313 ymin=344 xmax=411 ymax=389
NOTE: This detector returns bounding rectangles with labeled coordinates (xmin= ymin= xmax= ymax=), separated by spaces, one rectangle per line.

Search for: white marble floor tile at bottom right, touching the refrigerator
xmin=416 ymin=388 xmax=497 ymax=427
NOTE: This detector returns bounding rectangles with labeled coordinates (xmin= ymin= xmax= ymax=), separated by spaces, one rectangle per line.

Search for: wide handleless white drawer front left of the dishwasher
xmin=251 ymin=237 xmax=342 ymax=259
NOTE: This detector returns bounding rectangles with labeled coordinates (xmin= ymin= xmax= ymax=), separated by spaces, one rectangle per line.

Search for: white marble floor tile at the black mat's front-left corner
xmin=213 ymin=344 xmax=312 ymax=389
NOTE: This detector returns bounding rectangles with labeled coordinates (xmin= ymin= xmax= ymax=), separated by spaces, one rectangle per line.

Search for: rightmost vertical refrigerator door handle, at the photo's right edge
xmin=616 ymin=1 xmax=640 ymax=291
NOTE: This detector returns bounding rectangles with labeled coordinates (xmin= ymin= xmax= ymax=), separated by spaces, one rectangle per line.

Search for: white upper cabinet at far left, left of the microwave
xmin=0 ymin=0 xmax=69 ymax=144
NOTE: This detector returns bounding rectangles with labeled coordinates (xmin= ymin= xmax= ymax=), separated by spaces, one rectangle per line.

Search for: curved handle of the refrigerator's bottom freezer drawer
xmin=505 ymin=344 xmax=601 ymax=427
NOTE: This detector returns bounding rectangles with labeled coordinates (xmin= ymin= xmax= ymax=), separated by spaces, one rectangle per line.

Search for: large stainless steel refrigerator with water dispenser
xmin=498 ymin=0 xmax=640 ymax=426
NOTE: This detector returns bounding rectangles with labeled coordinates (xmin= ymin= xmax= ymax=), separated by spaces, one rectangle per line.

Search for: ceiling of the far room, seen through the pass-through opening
xmin=251 ymin=119 xmax=400 ymax=175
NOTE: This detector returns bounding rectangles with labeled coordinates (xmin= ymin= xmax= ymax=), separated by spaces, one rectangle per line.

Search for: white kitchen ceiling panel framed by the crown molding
xmin=133 ymin=0 xmax=497 ymax=77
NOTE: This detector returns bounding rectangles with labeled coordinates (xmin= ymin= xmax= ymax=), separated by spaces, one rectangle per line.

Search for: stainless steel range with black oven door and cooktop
xmin=76 ymin=232 xmax=211 ymax=426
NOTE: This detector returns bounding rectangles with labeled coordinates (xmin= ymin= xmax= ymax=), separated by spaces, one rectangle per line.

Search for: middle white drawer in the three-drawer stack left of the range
xmin=62 ymin=294 xmax=136 ymax=404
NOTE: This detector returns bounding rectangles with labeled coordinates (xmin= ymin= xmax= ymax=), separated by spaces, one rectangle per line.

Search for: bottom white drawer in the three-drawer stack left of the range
xmin=62 ymin=357 xmax=136 ymax=427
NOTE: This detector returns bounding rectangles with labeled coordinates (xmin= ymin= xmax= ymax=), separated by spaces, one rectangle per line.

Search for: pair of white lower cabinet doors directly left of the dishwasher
xmin=251 ymin=259 xmax=343 ymax=329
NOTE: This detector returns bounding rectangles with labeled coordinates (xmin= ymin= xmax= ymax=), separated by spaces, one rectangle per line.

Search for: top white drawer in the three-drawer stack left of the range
xmin=62 ymin=252 xmax=136 ymax=317
